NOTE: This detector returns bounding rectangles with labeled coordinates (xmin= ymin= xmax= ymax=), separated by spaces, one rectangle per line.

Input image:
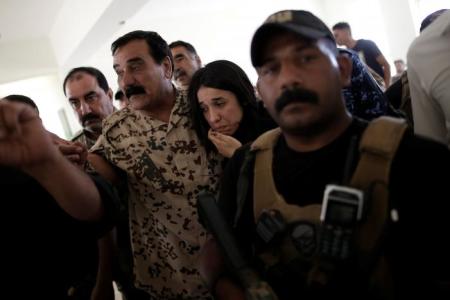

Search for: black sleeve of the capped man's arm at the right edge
xmin=390 ymin=134 xmax=450 ymax=291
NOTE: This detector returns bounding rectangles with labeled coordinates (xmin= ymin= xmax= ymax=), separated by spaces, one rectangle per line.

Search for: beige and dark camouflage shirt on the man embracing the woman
xmin=91 ymin=92 xmax=221 ymax=299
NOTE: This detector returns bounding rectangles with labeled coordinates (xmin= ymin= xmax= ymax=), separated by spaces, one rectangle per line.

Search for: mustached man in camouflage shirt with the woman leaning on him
xmin=89 ymin=31 xmax=221 ymax=299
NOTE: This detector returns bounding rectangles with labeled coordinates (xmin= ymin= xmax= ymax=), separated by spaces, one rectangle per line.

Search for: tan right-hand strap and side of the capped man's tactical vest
xmin=351 ymin=117 xmax=407 ymax=295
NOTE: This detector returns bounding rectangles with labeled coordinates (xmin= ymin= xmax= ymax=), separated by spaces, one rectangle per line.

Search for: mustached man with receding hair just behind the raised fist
xmin=62 ymin=67 xmax=115 ymax=299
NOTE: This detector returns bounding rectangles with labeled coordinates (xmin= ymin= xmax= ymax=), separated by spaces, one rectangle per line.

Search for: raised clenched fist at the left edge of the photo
xmin=0 ymin=101 xmax=58 ymax=168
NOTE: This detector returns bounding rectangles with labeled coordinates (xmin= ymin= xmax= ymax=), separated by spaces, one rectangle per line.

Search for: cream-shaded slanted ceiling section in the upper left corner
xmin=0 ymin=0 xmax=151 ymax=83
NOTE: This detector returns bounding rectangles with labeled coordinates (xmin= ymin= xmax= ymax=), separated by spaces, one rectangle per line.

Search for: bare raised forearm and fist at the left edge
xmin=0 ymin=101 xmax=104 ymax=221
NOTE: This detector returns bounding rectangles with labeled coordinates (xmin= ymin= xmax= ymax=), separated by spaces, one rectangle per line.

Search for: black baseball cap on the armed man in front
xmin=251 ymin=10 xmax=335 ymax=67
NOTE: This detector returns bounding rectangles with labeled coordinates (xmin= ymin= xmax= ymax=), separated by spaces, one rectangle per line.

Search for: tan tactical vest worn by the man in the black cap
xmin=243 ymin=117 xmax=407 ymax=298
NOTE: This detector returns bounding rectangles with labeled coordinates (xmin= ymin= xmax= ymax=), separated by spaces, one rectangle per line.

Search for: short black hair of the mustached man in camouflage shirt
xmin=111 ymin=30 xmax=173 ymax=71
